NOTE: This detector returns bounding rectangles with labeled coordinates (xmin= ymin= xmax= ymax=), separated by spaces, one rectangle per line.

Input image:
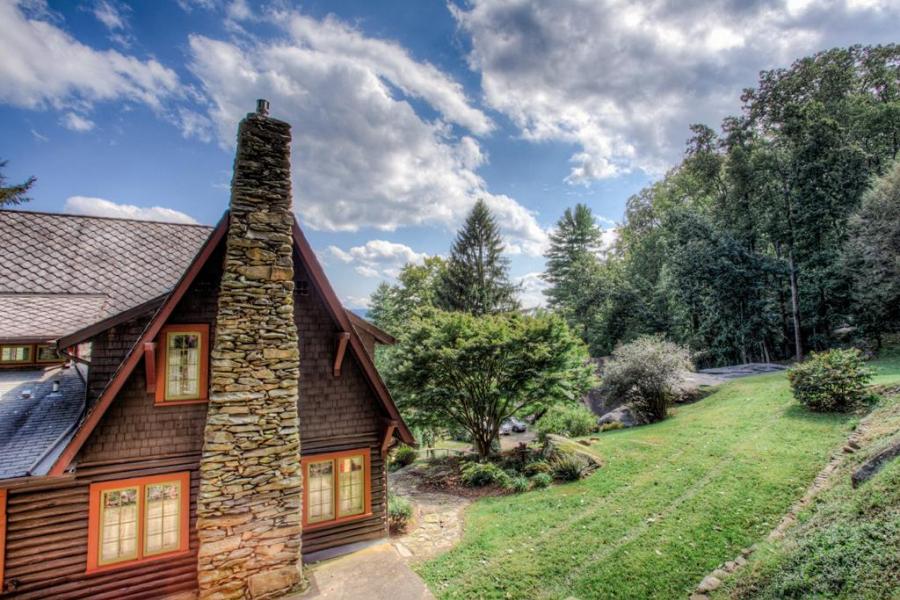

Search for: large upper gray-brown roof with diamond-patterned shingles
xmin=0 ymin=210 xmax=212 ymax=341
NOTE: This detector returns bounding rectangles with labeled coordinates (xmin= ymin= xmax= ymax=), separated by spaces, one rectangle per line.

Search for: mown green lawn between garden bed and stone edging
xmin=419 ymin=360 xmax=900 ymax=598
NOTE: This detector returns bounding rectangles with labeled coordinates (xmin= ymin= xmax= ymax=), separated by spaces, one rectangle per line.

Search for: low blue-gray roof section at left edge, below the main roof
xmin=0 ymin=366 xmax=85 ymax=479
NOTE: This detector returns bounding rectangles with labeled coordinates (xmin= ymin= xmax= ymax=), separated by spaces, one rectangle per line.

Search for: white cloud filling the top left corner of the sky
xmin=0 ymin=0 xmax=180 ymax=110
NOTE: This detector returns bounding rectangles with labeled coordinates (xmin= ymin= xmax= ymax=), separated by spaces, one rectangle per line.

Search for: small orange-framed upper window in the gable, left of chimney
xmin=156 ymin=325 xmax=209 ymax=404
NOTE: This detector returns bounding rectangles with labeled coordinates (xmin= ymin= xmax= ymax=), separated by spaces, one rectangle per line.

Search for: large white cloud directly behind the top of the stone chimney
xmin=189 ymin=13 xmax=546 ymax=254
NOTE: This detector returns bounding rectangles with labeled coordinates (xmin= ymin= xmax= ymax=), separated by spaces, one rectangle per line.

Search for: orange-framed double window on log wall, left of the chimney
xmin=87 ymin=473 xmax=190 ymax=572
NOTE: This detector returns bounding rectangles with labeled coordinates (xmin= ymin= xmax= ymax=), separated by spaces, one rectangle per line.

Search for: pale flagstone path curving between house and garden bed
xmin=388 ymin=467 xmax=472 ymax=563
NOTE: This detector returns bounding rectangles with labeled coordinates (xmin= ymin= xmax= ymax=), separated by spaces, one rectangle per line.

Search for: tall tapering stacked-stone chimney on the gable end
xmin=197 ymin=100 xmax=302 ymax=600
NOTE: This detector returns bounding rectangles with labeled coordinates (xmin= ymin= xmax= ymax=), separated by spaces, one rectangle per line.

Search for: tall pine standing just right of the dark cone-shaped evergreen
xmin=544 ymin=204 xmax=602 ymax=308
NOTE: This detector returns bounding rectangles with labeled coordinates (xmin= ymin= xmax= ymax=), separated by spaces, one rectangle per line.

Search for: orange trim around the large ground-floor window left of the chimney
xmin=87 ymin=472 xmax=191 ymax=573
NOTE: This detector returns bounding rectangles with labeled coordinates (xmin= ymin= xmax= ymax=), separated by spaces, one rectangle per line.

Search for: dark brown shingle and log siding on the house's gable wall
xmin=0 ymin=239 xmax=387 ymax=600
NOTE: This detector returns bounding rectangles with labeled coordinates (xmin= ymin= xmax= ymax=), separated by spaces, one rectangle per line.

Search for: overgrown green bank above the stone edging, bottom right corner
xmin=717 ymin=361 xmax=900 ymax=599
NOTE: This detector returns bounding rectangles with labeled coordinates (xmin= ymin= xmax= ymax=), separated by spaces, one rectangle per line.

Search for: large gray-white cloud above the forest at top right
xmin=451 ymin=0 xmax=900 ymax=184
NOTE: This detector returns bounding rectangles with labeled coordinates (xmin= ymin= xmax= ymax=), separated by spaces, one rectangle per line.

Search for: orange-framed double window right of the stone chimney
xmin=303 ymin=448 xmax=372 ymax=526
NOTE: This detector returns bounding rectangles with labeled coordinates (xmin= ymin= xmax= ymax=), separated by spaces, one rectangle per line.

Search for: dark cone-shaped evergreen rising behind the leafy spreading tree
xmin=437 ymin=200 xmax=519 ymax=315
